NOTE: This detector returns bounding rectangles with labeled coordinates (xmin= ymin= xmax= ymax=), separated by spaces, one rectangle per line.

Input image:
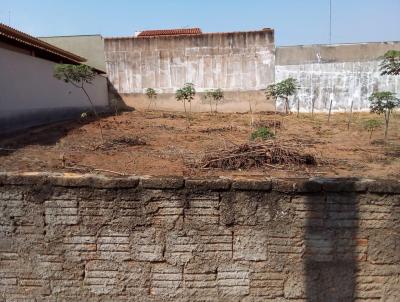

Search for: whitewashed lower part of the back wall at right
xmin=275 ymin=61 xmax=400 ymax=112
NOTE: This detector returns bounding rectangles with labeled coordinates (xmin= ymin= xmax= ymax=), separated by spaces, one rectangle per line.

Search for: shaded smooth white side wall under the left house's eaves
xmin=0 ymin=47 xmax=108 ymax=133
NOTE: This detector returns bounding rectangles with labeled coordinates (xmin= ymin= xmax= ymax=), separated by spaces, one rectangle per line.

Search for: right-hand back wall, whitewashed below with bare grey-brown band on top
xmin=275 ymin=42 xmax=400 ymax=112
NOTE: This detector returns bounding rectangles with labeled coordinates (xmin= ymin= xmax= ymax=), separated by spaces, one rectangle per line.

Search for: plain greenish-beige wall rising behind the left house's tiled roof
xmin=39 ymin=35 xmax=106 ymax=72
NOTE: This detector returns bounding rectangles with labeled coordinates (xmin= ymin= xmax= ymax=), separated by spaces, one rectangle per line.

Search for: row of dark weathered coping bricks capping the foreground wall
xmin=0 ymin=172 xmax=400 ymax=194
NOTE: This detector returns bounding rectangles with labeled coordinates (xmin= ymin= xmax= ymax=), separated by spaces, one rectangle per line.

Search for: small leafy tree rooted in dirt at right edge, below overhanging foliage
xmin=369 ymin=91 xmax=400 ymax=142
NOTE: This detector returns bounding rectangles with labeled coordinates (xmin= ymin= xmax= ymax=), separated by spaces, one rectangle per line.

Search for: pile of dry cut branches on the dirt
xmin=201 ymin=140 xmax=317 ymax=170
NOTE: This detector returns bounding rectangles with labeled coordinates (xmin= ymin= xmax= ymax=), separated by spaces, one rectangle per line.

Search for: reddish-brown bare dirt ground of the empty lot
xmin=0 ymin=111 xmax=400 ymax=179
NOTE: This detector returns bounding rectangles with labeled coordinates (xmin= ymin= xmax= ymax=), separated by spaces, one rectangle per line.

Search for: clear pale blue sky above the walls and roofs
xmin=0 ymin=0 xmax=400 ymax=45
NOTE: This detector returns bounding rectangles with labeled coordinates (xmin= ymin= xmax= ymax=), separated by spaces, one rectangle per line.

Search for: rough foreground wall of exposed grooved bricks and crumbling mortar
xmin=0 ymin=174 xmax=400 ymax=301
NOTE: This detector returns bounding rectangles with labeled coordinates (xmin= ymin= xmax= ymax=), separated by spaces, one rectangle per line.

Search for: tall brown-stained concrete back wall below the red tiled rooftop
xmin=105 ymin=30 xmax=275 ymax=111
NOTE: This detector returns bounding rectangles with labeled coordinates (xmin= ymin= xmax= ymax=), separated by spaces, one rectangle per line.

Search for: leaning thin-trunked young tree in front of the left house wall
xmin=54 ymin=64 xmax=104 ymax=142
